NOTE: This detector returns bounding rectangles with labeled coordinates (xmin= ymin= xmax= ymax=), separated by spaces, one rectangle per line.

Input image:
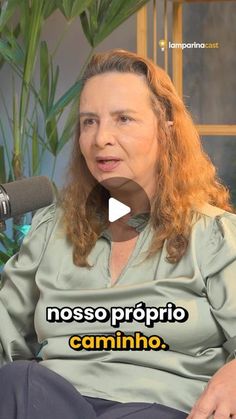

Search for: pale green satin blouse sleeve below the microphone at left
xmin=0 ymin=204 xmax=55 ymax=366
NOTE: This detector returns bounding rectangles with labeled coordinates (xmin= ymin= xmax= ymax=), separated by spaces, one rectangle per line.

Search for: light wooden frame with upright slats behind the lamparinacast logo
xmin=137 ymin=0 xmax=236 ymax=136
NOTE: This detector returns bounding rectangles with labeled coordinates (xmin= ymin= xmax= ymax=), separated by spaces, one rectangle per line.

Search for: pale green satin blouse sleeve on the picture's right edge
xmin=204 ymin=212 xmax=236 ymax=362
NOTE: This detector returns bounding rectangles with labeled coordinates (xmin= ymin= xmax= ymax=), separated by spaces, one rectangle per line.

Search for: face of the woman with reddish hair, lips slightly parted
xmin=79 ymin=72 xmax=158 ymax=193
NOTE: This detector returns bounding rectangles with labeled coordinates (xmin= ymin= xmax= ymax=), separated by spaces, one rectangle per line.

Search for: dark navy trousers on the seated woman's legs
xmin=0 ymin=361 xmax=187 ymax=419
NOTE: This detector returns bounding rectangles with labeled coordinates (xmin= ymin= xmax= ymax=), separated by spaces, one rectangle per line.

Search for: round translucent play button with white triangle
xmin=86 ymin=177 xmax=150 ymax=242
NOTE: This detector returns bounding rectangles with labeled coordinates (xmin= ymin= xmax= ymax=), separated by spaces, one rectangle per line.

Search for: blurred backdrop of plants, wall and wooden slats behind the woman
xmin=0 ymin=0 xmax=236 ymax=260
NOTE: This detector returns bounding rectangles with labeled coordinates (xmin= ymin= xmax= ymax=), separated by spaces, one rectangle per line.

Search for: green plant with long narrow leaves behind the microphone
xmin=0 ymin=0 xmax=149 ymax=264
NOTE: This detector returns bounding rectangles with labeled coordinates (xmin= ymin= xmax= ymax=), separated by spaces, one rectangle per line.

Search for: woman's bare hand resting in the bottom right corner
xmin=187 ymin=359 xmax=236 ymax=419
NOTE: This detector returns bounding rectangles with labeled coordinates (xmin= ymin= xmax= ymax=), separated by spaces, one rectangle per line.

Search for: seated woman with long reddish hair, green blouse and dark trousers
xmin=0 ymin=50 xmax=236 ymax=419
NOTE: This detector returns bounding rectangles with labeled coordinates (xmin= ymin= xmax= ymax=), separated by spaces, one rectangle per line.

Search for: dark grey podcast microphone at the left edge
xmin=0 ymin=176 xmax=54 ymax=221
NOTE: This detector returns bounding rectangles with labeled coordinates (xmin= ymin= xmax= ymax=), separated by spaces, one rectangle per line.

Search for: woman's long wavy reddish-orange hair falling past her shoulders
xmin=61 ymin=49 xmax=233 ymax=266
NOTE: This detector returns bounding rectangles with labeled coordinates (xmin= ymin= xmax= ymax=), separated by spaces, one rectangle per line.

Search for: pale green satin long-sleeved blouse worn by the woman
xmin=0 ymin=204 xmax=236 ymax=412
